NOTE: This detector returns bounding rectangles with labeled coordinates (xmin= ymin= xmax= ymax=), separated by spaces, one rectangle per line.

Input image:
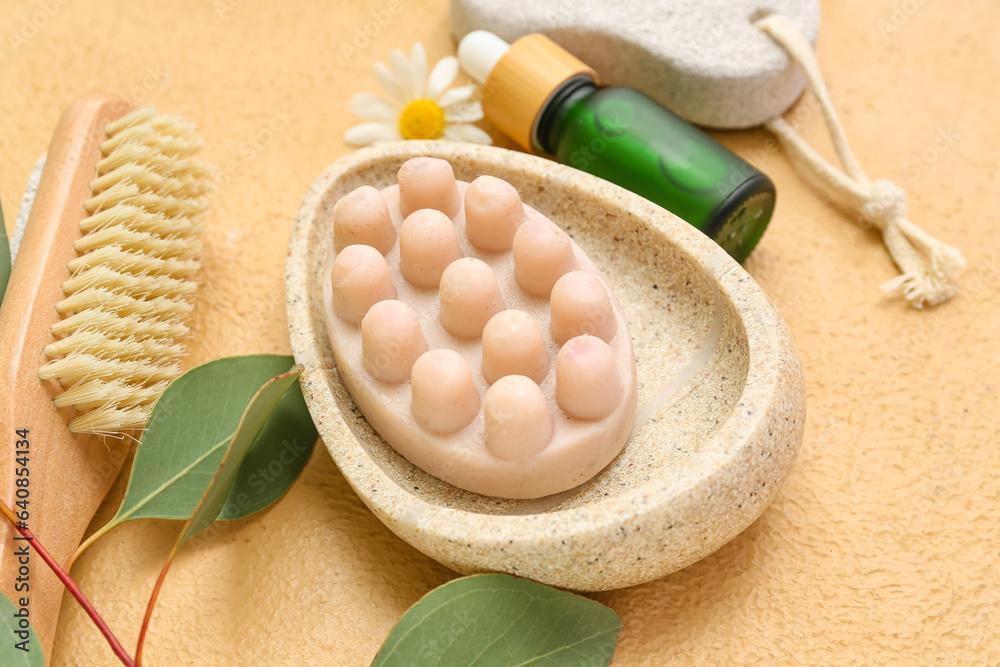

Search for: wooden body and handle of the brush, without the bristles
xmin=0 ymin=95 xmax=131 ymax=659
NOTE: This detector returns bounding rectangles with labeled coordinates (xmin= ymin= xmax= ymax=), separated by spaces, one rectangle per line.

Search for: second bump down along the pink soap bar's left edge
xmin=330 ymin=245 xmax=397 ymax=325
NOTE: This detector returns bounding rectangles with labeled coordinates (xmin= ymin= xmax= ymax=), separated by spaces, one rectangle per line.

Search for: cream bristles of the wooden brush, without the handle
xmin=38 ymin=109 xmax=212 ymax=434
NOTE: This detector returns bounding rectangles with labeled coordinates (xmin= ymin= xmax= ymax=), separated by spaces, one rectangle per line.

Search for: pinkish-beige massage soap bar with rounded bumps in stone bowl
xmin=324 ymin=158 xmax=636 ymax=498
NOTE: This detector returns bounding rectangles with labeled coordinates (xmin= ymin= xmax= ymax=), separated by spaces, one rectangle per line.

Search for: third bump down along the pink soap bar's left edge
xmin=361 ymin=300 xmax=427 ymax=384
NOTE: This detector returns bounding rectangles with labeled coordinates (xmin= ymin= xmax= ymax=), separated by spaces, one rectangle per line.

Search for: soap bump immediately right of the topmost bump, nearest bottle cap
xmin=465 ymin=176 xmax=525 ymax=252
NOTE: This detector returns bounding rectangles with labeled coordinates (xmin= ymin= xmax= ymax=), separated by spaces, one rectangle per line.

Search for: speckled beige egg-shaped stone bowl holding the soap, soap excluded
xmin=286 ymin=141 xmax=805 ymax=591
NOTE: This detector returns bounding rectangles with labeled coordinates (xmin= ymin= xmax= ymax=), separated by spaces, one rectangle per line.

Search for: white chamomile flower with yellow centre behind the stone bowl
xmin=344 ymin=42 xmax=492 ymax=146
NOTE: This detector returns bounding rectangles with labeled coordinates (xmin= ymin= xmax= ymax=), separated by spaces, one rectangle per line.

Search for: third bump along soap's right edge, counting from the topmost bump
xmin=513 ymin=219 xmax=576 ymax=297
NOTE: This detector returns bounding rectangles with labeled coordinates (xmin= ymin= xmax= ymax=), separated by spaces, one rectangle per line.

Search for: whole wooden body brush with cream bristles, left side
xmin=0 ymin=95 xmax=209 ymax=656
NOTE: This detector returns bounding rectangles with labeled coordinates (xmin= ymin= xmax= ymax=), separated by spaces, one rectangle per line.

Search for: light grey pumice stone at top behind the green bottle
xmin=450 ymin=0 xmax=820 ymax=130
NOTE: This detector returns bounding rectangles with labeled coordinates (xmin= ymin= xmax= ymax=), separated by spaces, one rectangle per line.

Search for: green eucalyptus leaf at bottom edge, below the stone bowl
xmin=373 ymin=574 xmax=621 ymax=667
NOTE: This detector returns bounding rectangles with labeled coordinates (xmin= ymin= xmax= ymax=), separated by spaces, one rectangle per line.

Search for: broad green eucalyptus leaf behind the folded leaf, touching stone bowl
xmin=77 ymin=355 xmax=317 ymax=555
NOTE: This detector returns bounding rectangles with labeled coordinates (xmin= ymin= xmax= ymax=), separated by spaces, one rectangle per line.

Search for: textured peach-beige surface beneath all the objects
xmin=0 ymin=0 xmax=1000 ymax=665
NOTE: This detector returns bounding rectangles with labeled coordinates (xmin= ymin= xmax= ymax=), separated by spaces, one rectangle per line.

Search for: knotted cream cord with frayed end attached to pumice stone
xmin=754 ymin=14 xmax=965 ymax=308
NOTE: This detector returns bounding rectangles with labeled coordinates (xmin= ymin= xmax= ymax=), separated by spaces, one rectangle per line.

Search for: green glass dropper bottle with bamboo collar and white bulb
xmin=459 ymin=31 xmax=775 ymax=262
